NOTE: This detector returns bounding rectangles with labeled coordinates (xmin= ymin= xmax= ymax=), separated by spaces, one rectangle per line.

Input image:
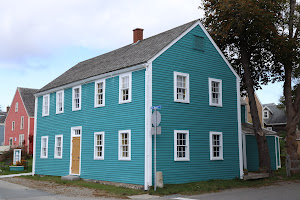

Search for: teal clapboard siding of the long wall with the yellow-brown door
xmin=36 ymin=70 xmax=145 ymax=185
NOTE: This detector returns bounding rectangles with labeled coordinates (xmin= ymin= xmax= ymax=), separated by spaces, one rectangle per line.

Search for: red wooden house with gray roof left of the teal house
xmin=4 ymin=87 xmax=38 ymax=154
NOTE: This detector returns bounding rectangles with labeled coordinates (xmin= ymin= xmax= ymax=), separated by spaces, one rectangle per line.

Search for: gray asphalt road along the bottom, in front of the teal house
xmin=0 ymin=180 xmax=300 ymax=200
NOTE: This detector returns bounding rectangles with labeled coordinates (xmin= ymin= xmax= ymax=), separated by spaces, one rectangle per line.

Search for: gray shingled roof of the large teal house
xmin=38 ymin=20 xmax=198 ymax=92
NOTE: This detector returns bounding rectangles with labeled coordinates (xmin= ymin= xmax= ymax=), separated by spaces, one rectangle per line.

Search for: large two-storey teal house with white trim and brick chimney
xmin=33 ymin=20 xmax=243 ymax=190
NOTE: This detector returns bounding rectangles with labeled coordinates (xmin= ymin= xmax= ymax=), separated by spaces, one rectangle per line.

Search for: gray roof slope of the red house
xmin=18 ymin=87 xmax=38 ymax=117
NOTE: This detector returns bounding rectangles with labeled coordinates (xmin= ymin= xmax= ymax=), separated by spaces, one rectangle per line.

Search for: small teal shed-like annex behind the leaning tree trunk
xmin=242 ymin=123 xmax=281 ymax=171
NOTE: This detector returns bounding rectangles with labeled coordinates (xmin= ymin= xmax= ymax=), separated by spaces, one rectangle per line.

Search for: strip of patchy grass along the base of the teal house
xmin=22 ymin=168 xmax=300 ymax=197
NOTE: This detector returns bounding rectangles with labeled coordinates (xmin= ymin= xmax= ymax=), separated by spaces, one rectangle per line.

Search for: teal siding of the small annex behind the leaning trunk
xmin=246 ymin=135 xmax=276 ymax=171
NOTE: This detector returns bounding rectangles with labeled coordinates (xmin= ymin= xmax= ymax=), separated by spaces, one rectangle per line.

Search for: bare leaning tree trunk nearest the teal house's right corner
xmin=241 ymin=45 xmax=272 ymax=175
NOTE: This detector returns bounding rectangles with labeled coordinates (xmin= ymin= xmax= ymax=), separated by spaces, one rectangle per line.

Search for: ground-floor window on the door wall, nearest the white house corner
xmin=119 ymin=130 xmax=131 ymax=160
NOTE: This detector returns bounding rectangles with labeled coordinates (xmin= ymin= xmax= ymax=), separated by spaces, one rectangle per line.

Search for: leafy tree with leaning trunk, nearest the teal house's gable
xmin=203 ymin=0 xmax=284 ymax=174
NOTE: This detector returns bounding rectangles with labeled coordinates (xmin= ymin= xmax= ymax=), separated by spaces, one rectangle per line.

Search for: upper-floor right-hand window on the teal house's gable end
xmin=209 ymin=78 xmax=222 ymax=107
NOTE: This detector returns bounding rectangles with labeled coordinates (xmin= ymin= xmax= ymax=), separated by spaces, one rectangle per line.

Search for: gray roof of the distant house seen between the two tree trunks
xmin=263 ymin=103 xmax=286 ymax=125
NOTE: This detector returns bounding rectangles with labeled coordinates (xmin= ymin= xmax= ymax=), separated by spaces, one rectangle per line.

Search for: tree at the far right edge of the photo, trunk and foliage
xmin=273 ymin=0 xmax=300 ymax=160
